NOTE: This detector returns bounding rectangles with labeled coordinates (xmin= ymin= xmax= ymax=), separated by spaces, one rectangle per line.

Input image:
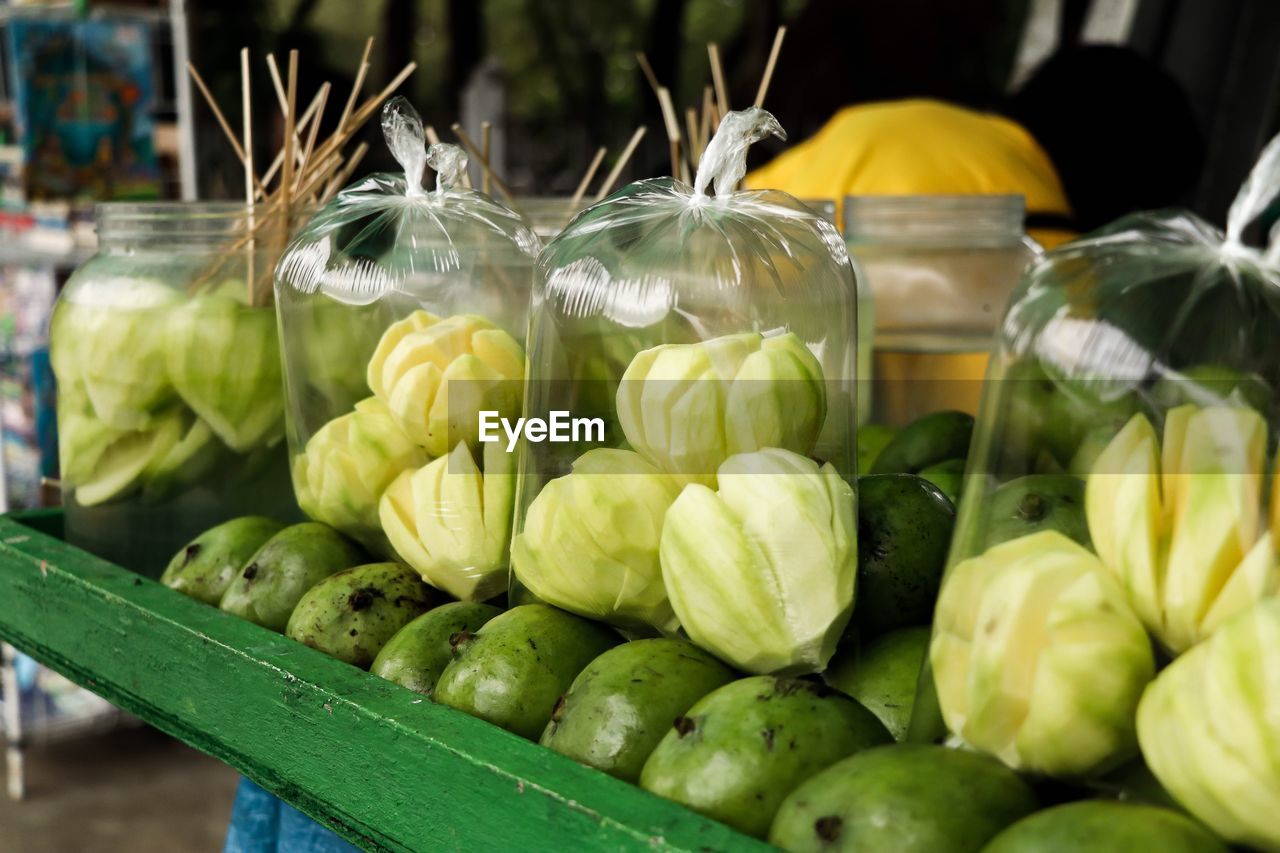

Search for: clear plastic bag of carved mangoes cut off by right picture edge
xmin=929 ymin=129 xmax=1280 ymax=845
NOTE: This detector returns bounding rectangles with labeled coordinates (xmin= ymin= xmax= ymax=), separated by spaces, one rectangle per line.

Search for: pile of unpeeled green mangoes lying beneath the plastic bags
xmin=163 ymin=404 xmax=1225 ymax=853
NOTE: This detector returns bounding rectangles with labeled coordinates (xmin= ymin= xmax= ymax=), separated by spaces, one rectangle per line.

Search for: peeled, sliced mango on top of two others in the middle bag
xmin=617 ymin=332 xmax=827 ymax=485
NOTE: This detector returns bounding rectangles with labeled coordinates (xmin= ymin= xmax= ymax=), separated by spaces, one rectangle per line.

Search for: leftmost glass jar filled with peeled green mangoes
xmin=50 ymin=202 xmax=297 ymax=575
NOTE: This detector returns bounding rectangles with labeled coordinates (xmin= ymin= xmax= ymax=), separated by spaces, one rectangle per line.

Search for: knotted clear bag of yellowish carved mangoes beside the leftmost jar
xmin=275 ymin=99 xmax=539 ymax=599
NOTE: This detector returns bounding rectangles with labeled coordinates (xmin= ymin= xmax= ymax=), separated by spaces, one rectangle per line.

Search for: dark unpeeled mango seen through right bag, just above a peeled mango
xmin=982 ymin=474 xmax=1091 ymax=548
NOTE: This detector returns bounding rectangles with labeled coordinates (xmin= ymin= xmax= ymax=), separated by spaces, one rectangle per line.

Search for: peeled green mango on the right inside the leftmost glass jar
xmin=165 ymin=293 xmax=284 ymax=453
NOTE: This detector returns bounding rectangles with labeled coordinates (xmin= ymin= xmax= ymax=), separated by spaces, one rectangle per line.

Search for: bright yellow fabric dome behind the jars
xmin=746 ymin=100 xmax=1075 ymax=248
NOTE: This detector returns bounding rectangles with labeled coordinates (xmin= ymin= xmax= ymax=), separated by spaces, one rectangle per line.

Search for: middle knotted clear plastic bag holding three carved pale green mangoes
xmin=512 ymin=109 xmax=856 ymax=672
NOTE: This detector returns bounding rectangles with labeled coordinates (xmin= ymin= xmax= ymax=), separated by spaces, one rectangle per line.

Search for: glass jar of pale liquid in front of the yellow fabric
xmin=845 ymin=195 xmax=1039 ymax=427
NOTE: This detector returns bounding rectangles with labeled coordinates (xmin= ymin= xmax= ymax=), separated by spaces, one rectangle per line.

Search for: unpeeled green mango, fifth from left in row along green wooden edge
xmin=435 ymin=605 xmax=620 ymax=740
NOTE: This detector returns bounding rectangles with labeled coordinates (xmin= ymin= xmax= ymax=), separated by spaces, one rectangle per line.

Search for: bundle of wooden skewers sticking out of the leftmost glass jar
xmin=187 ymin=37 xmax=416 ymax=306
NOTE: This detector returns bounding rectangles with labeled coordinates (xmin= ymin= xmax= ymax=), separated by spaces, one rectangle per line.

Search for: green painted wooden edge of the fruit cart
xmin=0 ymin=515 xmax=769 ymax=850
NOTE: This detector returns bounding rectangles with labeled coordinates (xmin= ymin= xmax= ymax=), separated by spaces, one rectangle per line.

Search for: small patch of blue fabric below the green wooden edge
xmin=223 ymin=779 xmax=360 ymax=853
